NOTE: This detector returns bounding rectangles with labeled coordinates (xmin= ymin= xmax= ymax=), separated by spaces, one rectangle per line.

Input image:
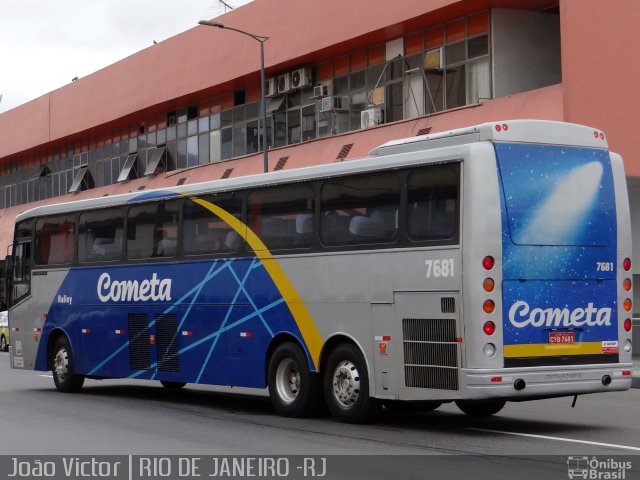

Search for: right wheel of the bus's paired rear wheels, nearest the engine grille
xmin=323 ymin=343 xmax=382 ymax=423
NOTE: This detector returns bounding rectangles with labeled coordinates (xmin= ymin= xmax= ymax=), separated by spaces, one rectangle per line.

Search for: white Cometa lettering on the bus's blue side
xmin=97 ymin=272 xmax=171 ymax=303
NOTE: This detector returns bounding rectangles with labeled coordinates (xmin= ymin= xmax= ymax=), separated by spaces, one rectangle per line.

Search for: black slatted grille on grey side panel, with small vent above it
xmin=402 ymin=318 xmax=459 ymax=390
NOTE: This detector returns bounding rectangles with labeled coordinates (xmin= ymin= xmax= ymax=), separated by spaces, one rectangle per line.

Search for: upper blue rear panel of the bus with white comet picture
xmin=495 ymin=143 xmax=616 ymax=246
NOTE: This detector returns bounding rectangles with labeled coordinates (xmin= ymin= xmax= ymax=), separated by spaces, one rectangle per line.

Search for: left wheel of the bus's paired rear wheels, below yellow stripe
xmin=268 ymin=342 xmax=322 ymax=417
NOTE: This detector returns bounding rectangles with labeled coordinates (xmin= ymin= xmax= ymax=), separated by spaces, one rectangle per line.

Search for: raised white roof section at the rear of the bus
xmin=369 ymin=120 xmax=608 ymax=156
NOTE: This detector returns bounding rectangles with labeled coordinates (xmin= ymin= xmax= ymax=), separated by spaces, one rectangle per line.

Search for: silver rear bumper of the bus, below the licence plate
xmin=461 ymin=363 xmax=632 ymax=401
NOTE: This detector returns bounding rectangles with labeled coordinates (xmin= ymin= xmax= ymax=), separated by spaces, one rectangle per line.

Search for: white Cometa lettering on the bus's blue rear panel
xmin=509 ymin=300 xmax=611 ymax=328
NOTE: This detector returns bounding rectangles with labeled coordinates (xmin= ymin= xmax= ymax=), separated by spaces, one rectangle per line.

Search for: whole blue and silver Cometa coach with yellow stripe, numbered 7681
xmin=9 ymin=120 xmax=632 ymax=422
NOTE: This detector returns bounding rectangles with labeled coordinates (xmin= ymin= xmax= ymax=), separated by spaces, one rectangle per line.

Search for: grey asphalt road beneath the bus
xmin=0 ymin=353 xmax=640 ymax=478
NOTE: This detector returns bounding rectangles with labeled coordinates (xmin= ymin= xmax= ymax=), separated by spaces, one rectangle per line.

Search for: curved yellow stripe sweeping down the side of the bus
xmin=191 ymin=197 xmax=322 ymax=370
